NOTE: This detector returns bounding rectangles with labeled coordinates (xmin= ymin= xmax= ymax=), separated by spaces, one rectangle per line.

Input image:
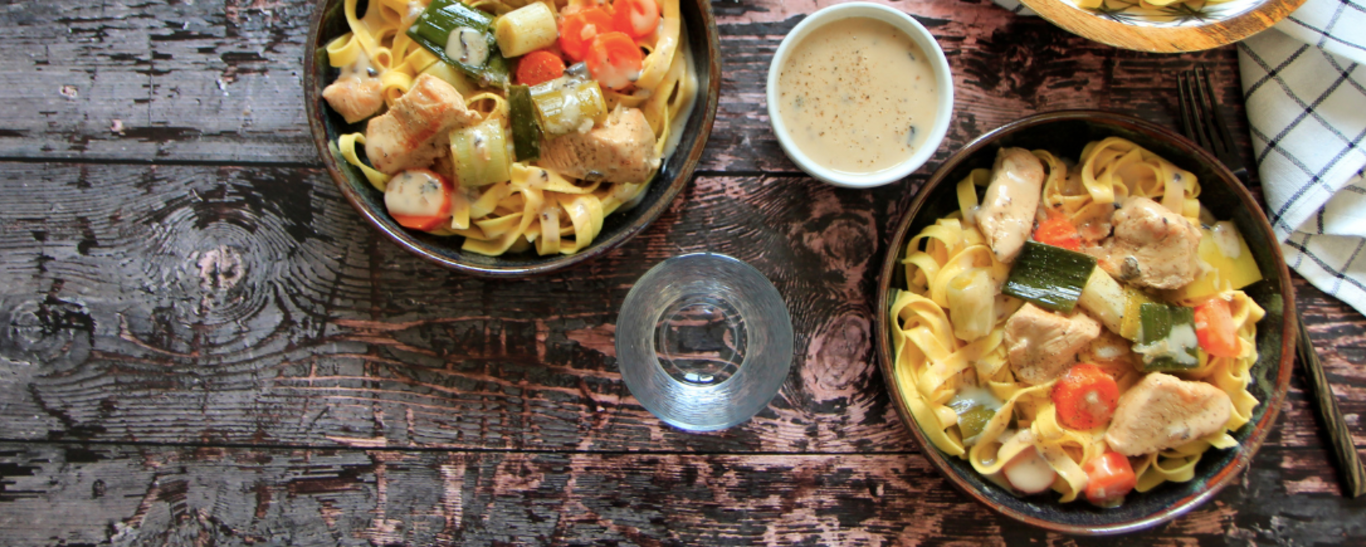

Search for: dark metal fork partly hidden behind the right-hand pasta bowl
xmin=1176 ymin=68 xmax=1366 ymax=498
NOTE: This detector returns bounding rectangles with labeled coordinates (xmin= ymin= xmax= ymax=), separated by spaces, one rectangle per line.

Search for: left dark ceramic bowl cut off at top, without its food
xmin=303 ymin=0 xmax=721 ymax=278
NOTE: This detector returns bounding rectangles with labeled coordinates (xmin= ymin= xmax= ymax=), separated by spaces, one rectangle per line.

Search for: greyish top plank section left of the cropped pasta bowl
xmin=0 ymin=0 xmax=317 ymax=163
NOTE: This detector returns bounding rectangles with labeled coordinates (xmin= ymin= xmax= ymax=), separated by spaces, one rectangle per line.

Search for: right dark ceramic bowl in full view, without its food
xmin=877 ymin=111 xmax=1295 ymax=535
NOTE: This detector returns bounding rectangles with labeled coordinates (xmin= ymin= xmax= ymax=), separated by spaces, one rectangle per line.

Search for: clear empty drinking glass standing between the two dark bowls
xmin=616 ymin=253 xmax=792 ymax=431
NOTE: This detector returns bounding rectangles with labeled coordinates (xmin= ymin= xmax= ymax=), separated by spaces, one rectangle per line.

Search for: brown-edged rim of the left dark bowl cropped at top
xmin=302 ymin=0 xmax=721 ymax=278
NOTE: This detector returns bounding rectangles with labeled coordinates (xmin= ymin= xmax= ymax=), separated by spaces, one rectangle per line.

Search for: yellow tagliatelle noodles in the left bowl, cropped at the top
xmin=326 ymin=0 xmax=697 ymax=256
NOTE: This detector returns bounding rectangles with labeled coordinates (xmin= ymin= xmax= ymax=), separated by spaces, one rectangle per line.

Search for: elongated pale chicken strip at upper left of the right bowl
xmin=977 ymin=148 xmax=1044 ymax=263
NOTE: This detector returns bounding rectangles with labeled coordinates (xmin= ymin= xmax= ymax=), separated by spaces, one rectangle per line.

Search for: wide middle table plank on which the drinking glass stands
xmin=0 ymin=163 xmax=1366 ymax=453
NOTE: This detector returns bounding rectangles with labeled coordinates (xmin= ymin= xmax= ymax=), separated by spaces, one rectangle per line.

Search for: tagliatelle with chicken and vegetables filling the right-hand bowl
xmin=889 ymin=138 xmax=1265 ymax=506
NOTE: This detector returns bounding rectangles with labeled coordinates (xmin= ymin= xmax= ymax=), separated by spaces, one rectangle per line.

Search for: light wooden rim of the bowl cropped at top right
xmin=1020 ymin=0 xmax=1305 ymax=53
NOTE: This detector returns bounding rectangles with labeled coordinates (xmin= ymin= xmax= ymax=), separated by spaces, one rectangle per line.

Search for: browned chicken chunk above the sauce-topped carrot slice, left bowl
xmin=365 ymin=74 xmax=479 ymax=175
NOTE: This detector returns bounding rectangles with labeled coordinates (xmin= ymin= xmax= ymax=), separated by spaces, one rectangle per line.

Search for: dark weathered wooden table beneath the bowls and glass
xmin=0 ymin=0 xmax=1366 ymax=546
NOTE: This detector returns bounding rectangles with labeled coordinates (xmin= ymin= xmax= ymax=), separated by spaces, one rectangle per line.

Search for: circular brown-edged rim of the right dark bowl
xmin=874 ymin=109 xmax=1298 ymax=536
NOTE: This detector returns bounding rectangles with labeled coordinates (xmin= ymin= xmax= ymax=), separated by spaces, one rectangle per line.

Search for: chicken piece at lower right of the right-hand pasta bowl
xmin=1105 ymin=372 xmax=1233 ymax=455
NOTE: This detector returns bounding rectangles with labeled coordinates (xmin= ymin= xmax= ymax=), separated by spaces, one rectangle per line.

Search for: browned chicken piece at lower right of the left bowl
xmin=538 ymin=107 xmax=660 ymax=182
